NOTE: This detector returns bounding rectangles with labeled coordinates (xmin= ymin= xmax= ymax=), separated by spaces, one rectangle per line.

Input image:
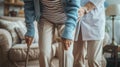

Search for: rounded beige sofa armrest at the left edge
xmin=0 ymin=29 xmax=12 ymax=65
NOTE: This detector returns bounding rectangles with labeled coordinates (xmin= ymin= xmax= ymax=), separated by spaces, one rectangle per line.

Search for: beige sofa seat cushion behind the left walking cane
xmin=8 ymin=43 xmax=39 ymax=61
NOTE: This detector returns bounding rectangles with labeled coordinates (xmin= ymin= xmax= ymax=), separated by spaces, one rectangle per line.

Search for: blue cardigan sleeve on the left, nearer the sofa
xmin=24 ymin=0 xmax=35 ymax=37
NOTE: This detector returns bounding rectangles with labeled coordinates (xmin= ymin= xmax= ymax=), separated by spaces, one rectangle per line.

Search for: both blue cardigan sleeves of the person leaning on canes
xmin=24 ymin=0 xmax=80 ymax=40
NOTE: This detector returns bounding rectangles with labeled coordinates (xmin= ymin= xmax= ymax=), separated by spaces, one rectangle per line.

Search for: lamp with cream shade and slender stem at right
xmin=106 ymin=4 xmax=120 ymax=45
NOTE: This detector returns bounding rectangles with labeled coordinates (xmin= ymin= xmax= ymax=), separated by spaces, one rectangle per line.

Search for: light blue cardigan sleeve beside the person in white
xmin=62 ymin=0 xmax=80 ymax=40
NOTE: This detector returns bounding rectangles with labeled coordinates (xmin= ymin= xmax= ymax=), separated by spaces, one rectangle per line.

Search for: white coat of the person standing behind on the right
xmin=81 ymin=0 xmax=105 ymax=40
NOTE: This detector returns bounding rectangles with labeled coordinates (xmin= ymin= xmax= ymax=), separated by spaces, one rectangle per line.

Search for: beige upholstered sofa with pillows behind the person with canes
xmin=0 ymin=17 xmax=58 ymax=67
